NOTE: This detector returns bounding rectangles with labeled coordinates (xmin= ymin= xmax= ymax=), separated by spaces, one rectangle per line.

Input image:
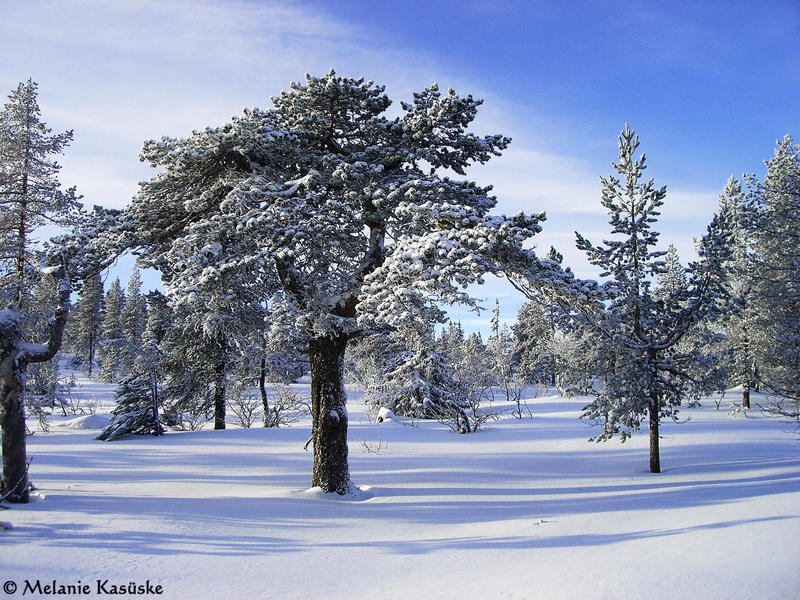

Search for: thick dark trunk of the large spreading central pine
xmin=308 ymin=336 xmax=350 ymax=494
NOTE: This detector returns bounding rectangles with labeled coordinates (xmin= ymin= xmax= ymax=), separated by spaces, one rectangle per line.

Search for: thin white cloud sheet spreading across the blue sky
xmin=0 ymin=0 xmax=728 ymax=332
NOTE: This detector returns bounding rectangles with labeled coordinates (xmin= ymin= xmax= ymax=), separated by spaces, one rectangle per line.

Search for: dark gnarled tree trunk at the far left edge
xmin=0 ymin=352 xmax=29 ymax=503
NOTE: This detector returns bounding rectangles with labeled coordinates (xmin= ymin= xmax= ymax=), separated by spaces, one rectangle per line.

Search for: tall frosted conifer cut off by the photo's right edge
xmin=747 ymin=135 xmax=800 ymax=408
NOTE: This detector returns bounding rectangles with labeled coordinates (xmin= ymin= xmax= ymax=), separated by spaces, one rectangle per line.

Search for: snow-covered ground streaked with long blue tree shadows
xmin=0 ymin=370 xmax=800 ymax=600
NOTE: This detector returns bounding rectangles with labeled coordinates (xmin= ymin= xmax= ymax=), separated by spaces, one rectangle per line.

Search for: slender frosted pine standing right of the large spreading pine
xmin=576 ymin=125 xmax=727 ymax=473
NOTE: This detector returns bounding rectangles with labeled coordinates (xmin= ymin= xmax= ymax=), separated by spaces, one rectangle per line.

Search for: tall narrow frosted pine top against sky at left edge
xmin=0 ymin=79 xmax=78 ymax=312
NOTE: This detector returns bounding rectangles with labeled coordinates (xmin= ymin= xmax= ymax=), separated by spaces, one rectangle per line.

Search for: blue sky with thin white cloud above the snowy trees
xmin=0 ymin=0 xmax=800 ymax=329
